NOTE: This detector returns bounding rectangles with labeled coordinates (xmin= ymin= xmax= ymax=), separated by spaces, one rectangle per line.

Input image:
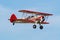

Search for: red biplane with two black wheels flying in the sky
xmin=9 ymin=10 xmax=53 ymax=29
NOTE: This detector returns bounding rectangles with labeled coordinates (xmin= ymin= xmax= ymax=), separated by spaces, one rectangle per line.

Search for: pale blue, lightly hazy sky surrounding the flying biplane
xmin=0 ymin=0 xmax=60 ymax=40
